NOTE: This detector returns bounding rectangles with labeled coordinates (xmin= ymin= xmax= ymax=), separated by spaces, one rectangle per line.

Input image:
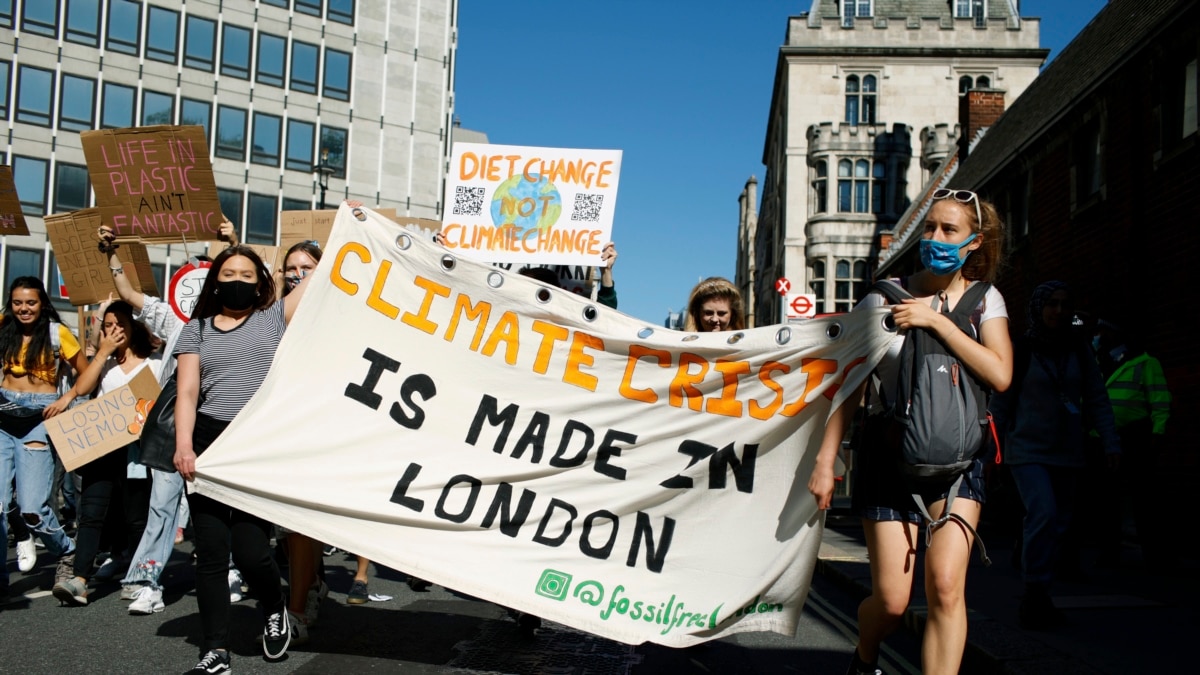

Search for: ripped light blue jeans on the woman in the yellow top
xmin=0 ymin=389 xmax=74 ymax=581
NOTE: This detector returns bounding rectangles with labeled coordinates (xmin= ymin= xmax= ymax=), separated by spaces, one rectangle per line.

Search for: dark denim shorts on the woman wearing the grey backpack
xmin=850 ymin=448 xmax=984 ymax=522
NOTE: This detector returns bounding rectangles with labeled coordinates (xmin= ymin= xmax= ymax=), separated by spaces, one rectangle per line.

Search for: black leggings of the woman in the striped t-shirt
xmin=187 ymin=414 xmax=287 ymax=651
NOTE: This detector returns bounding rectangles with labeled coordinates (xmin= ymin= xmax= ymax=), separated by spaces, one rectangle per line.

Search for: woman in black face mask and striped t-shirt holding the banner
xmin=175 ymin=246 xmax=305 ymax=674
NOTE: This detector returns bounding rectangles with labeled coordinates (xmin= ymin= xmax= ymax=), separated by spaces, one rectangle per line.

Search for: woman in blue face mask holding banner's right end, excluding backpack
xmin=809 ymin=189 xmax=1013 ymax=675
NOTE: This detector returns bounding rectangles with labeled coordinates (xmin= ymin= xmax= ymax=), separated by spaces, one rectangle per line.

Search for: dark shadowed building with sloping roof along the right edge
xmin=878 ymin=0 xmax=1200 ymax=466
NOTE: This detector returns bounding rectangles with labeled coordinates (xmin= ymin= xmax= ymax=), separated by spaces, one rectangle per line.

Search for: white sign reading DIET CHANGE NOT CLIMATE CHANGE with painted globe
xmin=442 ymin=143 xmax=620 ymax=265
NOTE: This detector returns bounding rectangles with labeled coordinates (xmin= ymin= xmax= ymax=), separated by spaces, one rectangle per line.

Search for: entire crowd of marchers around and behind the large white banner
xmin=0 ymin=190 xmax=1170 ymax=674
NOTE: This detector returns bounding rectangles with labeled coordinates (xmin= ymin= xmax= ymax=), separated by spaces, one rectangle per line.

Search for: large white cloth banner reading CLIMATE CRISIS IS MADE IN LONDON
xmin=194 ymin=207 xmax=890 ymax=646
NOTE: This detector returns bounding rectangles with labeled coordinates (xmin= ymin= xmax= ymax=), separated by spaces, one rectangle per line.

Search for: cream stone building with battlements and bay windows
xmin=737 ymin=0 xmax=1048 ymax=325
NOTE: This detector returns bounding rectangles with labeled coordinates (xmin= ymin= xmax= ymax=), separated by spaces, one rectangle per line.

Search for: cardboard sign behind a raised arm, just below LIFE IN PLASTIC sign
xmin=46 ymin=209 xmax=160 ymax=307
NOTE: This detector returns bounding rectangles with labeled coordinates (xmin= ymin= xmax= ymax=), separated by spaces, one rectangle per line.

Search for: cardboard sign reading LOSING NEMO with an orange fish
xmin=46 ymin=368 xmax=161 ymax=471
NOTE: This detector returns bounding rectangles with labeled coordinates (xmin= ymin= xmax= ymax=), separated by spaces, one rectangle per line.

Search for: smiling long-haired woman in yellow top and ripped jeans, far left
xmin=0 ymin=276 xmax=88 ymax=591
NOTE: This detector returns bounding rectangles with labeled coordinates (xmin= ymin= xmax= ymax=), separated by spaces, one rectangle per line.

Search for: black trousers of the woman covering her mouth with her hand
xmin=74 ymin=448 xmax=150 ymax=579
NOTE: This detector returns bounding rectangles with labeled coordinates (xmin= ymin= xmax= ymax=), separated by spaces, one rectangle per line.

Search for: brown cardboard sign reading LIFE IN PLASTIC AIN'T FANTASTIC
xmin=79 ymin=126 xmax=223 ymax=241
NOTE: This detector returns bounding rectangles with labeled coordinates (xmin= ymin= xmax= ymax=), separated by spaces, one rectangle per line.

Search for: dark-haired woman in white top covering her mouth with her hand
xmin=53 ymin=300 xmax=162 ymax=605
